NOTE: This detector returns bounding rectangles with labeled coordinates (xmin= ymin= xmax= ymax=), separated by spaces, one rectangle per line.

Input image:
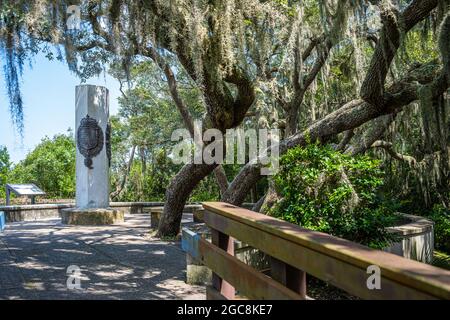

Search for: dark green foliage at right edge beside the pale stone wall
xmin=429 ymin=205 xmax=450 ymax=253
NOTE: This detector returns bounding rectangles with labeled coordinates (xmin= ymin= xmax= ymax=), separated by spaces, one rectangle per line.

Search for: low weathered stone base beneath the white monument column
xmin=61 ymin=208 xmax=124 ymax=226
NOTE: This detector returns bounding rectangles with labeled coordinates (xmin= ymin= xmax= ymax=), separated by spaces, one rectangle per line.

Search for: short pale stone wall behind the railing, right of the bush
xmin=384 ymin=213 xmax=434 ymax=263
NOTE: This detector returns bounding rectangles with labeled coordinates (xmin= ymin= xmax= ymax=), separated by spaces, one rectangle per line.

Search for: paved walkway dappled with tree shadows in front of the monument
xmin=0 ymin=215 xmax=205 ymax=300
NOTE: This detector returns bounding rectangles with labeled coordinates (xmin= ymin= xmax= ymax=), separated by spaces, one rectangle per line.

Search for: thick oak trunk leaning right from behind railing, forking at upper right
xmin=224 ymin=1 xmax=450 ymax=210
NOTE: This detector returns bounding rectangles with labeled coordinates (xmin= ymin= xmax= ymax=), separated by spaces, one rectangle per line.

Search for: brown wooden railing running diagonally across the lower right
xmin=182 ymin=202 xmax=450 ymax=299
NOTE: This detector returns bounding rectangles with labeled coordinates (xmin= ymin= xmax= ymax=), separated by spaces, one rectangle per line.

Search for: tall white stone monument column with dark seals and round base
xmin=61 ymin=85 xmax=123 ymax=225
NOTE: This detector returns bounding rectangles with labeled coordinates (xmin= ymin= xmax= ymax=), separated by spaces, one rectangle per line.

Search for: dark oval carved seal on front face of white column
xmin=77 ymin=115 xmax=103 ymax=169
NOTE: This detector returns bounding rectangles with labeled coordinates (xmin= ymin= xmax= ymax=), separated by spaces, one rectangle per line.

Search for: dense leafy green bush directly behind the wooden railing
xmin=270 ymin=144 xmax=396 ymax=248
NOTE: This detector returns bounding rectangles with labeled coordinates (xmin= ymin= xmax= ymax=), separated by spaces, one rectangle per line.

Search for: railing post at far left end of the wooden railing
xmin=211 ymin=228 xmax=236 ymax=300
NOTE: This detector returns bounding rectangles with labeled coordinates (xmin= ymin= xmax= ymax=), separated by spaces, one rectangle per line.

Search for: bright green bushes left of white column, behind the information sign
xmin=9 ymin=131 xmax=75 ymax=198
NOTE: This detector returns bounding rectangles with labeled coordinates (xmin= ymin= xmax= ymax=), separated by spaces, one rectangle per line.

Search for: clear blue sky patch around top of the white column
xmin=0 ymin=55 xmax=120 ymax=163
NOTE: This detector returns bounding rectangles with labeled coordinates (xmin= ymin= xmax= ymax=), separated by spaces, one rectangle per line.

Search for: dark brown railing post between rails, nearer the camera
xmin=270 ymin=257 xmax=306 ymax=299
